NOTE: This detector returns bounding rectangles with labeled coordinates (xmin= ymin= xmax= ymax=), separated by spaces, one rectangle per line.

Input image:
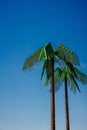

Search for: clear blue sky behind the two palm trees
xmin=0 ymin=0 xmax=87 ymax=130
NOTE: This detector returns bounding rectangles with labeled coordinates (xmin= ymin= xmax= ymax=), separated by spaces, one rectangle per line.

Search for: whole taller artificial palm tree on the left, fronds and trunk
xmin=23 ymin=42 xmax=79 ymax=130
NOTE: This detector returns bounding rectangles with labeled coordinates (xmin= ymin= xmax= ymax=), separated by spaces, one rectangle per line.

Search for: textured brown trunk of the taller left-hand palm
xmin=51 ymin=59 xmax=55 ymax=130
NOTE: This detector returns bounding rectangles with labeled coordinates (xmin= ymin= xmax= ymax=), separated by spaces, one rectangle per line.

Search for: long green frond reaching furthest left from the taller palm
xmin=23 ymin=47 xmax=43 ymax=70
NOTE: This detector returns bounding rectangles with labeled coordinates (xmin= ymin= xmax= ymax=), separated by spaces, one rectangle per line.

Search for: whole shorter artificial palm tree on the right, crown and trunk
xmin=54 ymin=62 xmax=87 ymax=130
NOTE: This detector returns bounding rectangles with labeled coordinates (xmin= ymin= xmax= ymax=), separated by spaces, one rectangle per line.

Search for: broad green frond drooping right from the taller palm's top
xmin=55 ymin=44 xmax=80 ymax=65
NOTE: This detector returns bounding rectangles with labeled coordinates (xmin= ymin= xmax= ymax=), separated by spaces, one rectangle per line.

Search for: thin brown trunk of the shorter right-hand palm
xmin=65 ymin=77 xmax=70 ymax=130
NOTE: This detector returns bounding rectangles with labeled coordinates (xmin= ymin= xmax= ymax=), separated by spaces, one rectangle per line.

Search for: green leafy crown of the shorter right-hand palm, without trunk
xmin=54 ymin=63 xmax=87 ymax=93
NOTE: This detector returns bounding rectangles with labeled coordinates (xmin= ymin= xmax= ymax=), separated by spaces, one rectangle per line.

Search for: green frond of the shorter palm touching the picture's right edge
xmin=75 ymin=67 xmax=87 ymax=84
